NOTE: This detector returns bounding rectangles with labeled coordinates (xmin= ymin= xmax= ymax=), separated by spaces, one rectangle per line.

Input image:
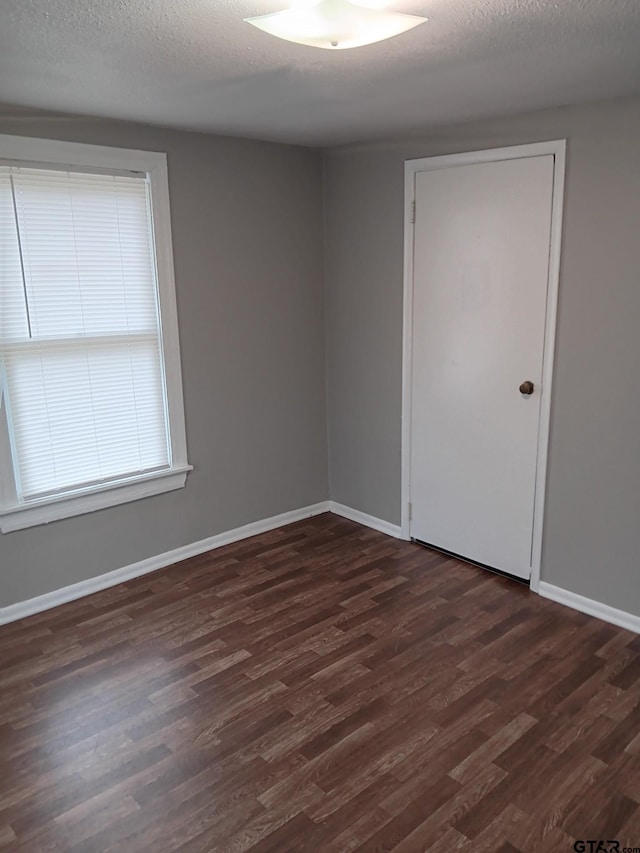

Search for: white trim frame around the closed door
xmin=401 ymin=139 xmax=566 ymax=592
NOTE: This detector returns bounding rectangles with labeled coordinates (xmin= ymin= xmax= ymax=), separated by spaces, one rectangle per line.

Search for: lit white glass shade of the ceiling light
xmin=245 ymin=0 xmax=427 ymax=50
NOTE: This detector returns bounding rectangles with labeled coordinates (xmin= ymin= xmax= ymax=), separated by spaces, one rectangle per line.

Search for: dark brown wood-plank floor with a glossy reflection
xmin=0 ymin=515 xmax=640 ymax=853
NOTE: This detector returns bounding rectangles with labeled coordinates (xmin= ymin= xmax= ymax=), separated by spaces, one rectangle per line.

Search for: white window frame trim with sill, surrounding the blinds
xmin=0 ymin=134 xmax=192 ymax=533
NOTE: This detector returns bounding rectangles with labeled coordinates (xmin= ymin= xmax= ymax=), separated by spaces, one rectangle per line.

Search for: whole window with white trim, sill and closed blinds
xmin=0 ymin=136 xmax=189 ymax=532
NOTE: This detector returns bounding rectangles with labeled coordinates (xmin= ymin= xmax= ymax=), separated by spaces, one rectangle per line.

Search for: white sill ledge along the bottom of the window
xmin=0 ymin=465 xmax=192 ymax=533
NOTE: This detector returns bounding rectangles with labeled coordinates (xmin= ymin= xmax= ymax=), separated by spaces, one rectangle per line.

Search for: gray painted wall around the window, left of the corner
xmin=0 ymin=108 xmax=328 ymax=606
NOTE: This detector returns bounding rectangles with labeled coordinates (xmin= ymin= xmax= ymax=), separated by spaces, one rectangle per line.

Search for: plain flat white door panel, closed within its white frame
xmin=409 ymin=154 xmax=554 ymax=578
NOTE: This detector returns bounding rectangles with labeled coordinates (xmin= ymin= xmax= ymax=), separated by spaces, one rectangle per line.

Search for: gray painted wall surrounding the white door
xmin=324 ymin=98 xmax=640 ymax=614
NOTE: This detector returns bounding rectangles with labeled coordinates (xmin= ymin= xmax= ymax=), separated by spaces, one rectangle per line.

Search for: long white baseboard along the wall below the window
xmin=0 ymin=501 xmax=329 ymax=625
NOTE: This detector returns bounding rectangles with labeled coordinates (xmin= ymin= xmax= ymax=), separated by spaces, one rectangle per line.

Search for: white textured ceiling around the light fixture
xmin=0 ymin=0 xmax=640 ymax=145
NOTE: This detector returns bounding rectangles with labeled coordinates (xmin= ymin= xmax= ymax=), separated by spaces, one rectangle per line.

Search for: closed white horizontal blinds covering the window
xmin=0 ymin=165 xmax=171 ymax=500
